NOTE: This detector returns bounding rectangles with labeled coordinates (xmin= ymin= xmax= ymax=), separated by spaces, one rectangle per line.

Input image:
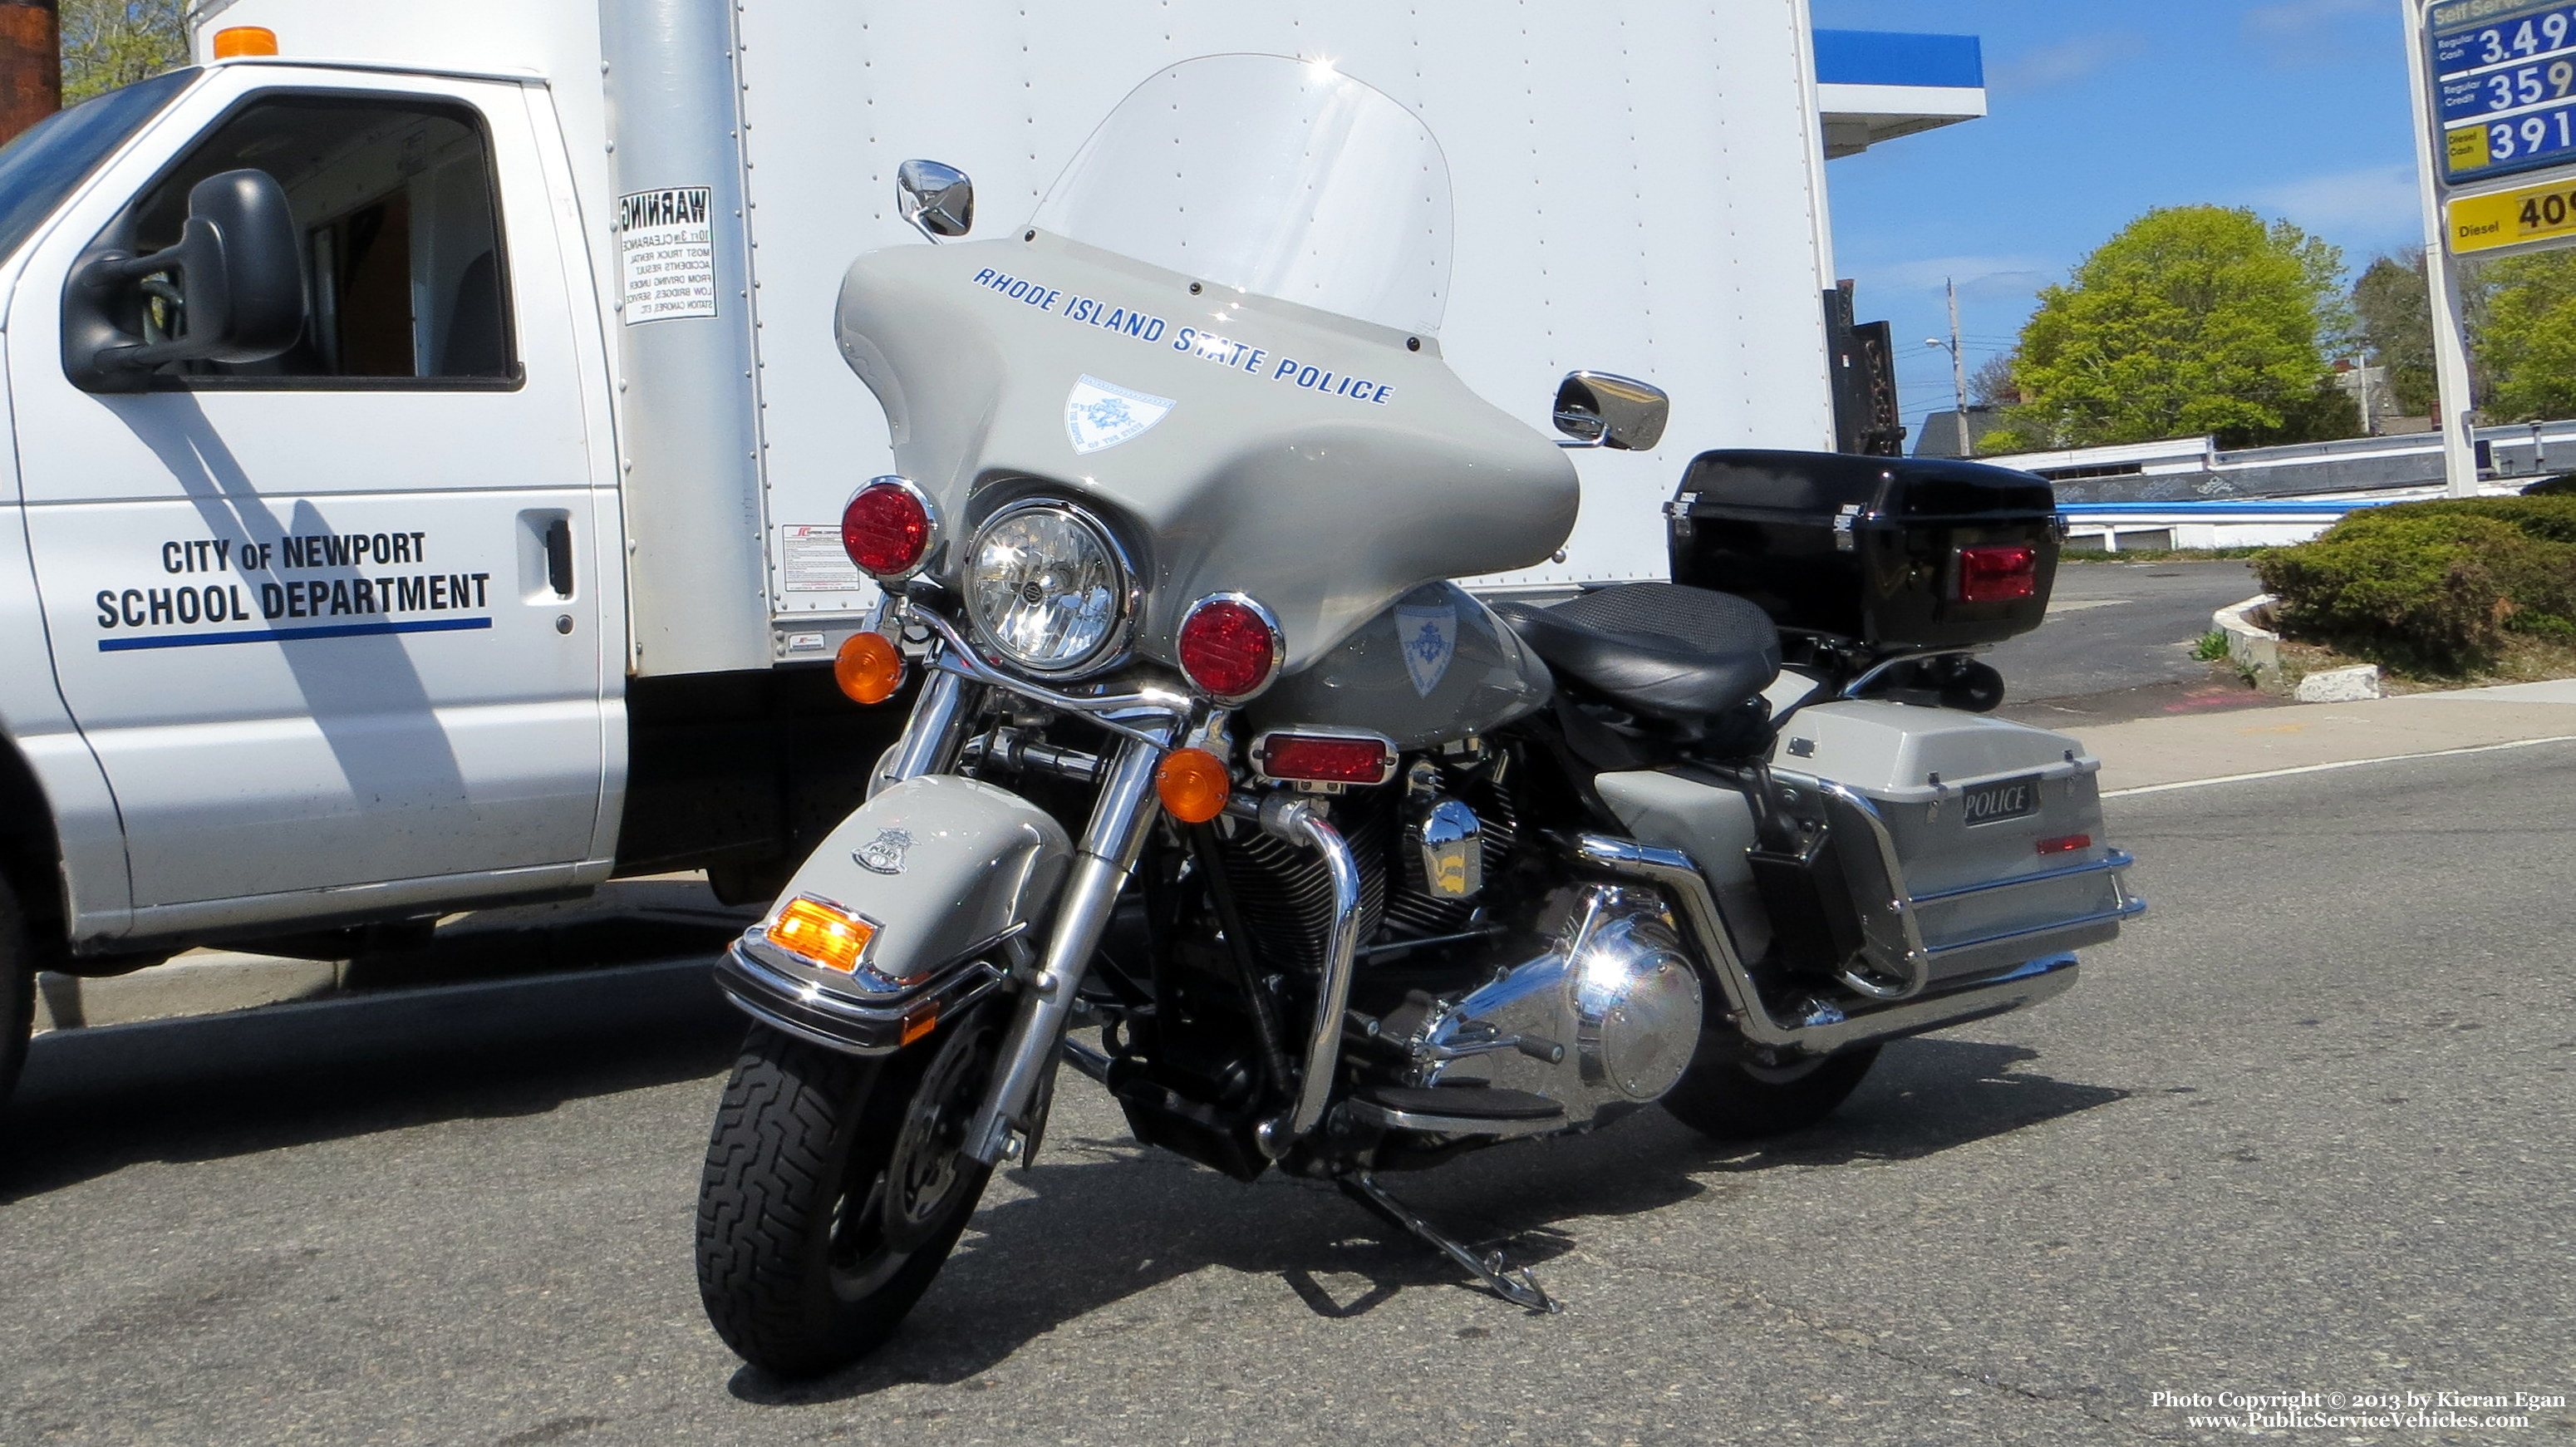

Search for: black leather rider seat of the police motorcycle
xmin=1494 ymin=582 xmax=1780 ymax=724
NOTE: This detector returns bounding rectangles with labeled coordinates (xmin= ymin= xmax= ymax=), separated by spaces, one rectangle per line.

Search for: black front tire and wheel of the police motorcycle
xmin=698 ymin=1007 xmax=1005 ymax=1377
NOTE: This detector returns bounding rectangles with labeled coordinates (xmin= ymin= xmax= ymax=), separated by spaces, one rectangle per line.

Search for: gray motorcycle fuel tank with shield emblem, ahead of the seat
xmin=1244 ymin=582 xmax=1553 ymax=749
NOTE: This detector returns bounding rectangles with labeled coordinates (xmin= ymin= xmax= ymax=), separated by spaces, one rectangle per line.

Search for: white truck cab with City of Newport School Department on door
xmin=0 ymin=51 xmax=897 ymax=1096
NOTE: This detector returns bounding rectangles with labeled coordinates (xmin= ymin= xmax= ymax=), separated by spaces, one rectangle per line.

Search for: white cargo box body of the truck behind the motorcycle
xmin=201 ymin=0 xmax=1865 ymax=620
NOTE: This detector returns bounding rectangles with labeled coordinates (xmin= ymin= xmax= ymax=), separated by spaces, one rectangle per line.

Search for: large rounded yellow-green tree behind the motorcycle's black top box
xmin=2004 ymin=206 xmax=2360 ymax=448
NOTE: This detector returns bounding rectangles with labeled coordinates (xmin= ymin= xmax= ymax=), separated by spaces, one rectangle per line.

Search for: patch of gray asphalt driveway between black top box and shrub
xmin=1986 ymin=561 xmax=2262 ymax=724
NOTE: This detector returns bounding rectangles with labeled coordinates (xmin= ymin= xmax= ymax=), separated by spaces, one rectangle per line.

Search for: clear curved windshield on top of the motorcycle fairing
xmin=1030 ymin=54 xmax=1450 ymax=335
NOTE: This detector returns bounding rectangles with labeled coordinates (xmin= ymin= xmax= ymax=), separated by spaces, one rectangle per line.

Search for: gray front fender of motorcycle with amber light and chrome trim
xmin=716 ymin=775 xmax=1074 ymax=1056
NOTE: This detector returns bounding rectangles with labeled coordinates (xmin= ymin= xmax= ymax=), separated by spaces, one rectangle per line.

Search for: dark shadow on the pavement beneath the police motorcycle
xmin=729 ymin=1041 xmax=2128 ymax=1405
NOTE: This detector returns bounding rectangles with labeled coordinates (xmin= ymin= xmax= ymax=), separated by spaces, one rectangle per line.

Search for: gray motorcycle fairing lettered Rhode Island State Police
xmin=838 ymin=232 xmax=1576 ymax=672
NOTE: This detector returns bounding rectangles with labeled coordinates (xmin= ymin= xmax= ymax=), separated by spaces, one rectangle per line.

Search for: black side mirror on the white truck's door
xmin=61 ymin=170 xmax=304 ymax=391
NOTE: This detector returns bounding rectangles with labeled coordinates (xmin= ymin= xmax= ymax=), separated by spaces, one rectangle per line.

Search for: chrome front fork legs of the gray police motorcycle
xmin=868 ymin=669 xmax=1164 ymax=1166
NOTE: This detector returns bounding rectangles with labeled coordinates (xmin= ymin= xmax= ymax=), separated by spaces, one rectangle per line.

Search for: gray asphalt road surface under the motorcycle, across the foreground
xmin=0 ymin=744 xmax=2576 ymax=1447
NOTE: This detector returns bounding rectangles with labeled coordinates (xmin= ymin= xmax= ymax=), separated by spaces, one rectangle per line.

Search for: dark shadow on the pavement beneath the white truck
xmin=0 ymin=957 xmax=745 ymax=1205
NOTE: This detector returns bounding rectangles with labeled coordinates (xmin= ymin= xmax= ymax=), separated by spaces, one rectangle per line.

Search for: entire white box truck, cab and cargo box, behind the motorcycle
xmin=0 ymin=0 xmax=1937 ymax=1096
